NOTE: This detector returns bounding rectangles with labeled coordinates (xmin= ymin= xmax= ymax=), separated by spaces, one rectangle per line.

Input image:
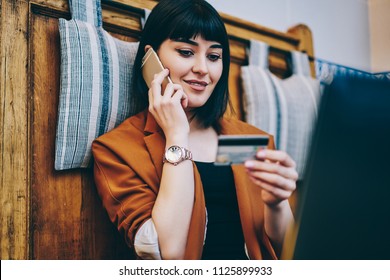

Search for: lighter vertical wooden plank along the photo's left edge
xmin=0 ymin=0 xmax=30 ymax=259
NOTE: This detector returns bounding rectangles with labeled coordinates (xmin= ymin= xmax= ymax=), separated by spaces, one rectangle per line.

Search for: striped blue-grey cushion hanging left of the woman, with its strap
xmin=55 ymin=0 xmax=138 ymax=170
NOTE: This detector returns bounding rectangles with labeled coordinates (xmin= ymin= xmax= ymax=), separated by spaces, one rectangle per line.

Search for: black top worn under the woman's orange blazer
xmin=195 ymin=162 xmax=248 ymax=260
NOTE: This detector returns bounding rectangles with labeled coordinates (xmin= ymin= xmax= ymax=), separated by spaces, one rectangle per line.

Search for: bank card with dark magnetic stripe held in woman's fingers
xmin=214 ymin=135 xmax=269 ymax=165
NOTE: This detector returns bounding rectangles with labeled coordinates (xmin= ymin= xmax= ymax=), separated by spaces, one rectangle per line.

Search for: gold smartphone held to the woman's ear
xmin=141 ymin=48 xmax=172 ymax=88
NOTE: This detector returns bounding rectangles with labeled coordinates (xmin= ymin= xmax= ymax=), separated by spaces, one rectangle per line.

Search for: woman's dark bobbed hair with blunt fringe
xmin=131 ymin=0 xmax=230 ymax=127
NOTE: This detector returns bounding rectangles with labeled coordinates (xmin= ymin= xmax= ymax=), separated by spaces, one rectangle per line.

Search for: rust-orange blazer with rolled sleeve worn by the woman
xmin=92 ymin=111 xmax=276 ymax=259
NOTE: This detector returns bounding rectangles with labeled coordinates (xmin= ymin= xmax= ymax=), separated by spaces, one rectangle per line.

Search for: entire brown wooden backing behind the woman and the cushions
xmin=0 ymin=0 xmax=314 ymax=259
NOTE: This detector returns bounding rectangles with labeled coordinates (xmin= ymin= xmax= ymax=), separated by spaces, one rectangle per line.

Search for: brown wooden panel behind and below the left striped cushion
xmin=31 ymin=12 xmax=135 ymax=259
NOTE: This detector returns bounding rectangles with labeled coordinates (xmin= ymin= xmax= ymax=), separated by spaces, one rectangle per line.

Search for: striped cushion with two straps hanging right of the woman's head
xmin=241 ymin=41 xmax=320 ymax=179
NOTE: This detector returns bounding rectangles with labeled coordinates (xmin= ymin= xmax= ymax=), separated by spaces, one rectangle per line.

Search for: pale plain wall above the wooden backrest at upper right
xmin=208 ymin=0 xmax=390 ymax=79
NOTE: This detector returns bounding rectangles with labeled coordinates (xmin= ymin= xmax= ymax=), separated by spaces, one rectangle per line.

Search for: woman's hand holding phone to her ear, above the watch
xmin=149 ymin=69 xmax=190 ymax=141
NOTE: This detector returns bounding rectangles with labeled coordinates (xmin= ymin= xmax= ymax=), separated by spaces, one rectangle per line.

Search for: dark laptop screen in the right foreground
xmin=283 ymin=78 xmax=390 ymax=260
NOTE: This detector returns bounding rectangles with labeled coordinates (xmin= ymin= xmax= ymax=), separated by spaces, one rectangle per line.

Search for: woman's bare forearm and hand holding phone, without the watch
xmin=149 ymin=70 xmax=195 ymax=259
